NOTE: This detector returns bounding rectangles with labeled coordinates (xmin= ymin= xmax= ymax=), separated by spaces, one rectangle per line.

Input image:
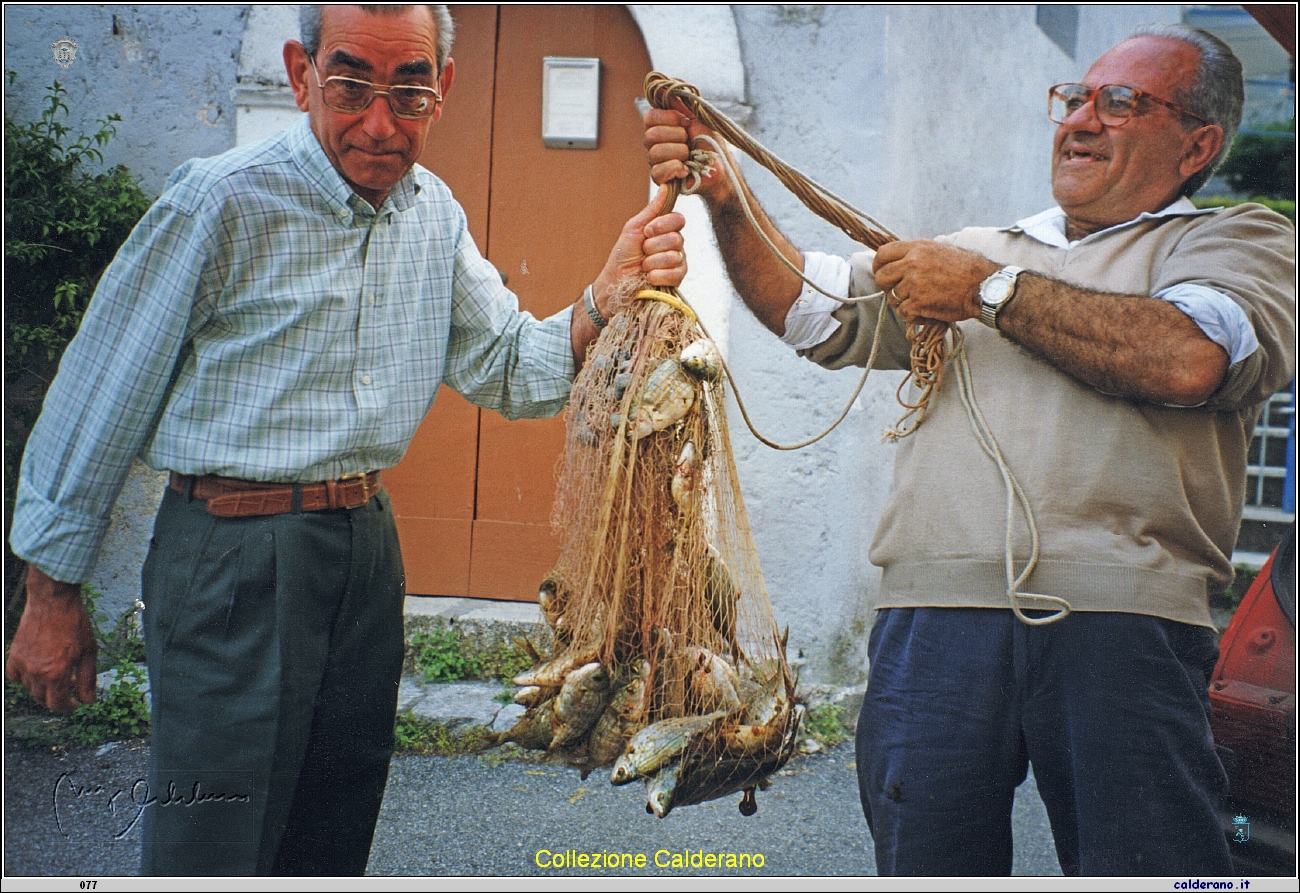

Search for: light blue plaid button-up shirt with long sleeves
xmin=10 ymin=118 xmax=573 ymax=581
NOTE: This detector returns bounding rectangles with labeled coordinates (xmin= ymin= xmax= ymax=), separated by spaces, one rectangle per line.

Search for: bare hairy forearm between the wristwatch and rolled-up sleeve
xmin=998 ymin=273 xmax=1229 ymax=406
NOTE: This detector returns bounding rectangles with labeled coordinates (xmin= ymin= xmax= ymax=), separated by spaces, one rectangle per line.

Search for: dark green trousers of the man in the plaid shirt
xmin=137 ymin=489 xmax=406 ymax=875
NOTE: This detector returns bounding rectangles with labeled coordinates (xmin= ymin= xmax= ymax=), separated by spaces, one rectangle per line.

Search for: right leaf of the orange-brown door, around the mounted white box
xmin=469 ymin=5 xmax=650 ymax=599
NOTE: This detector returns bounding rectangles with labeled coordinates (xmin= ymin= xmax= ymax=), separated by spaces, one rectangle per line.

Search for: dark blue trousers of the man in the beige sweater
xmin=857 ymin=608 xmax=1232 ymax=876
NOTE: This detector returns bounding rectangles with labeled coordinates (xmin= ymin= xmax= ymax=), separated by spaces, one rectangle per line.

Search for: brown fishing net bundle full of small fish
xmin=497 ymin=290 xmax=803 ymax=816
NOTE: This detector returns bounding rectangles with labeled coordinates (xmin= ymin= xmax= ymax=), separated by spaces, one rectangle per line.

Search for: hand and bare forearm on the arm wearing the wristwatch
xmin=874 ymin=240 xmax=1229 ymax=406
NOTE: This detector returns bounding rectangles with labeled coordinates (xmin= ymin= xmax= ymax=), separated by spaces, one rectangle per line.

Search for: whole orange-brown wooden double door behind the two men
xmin=385 ymin=6 xmax=650 ymax=601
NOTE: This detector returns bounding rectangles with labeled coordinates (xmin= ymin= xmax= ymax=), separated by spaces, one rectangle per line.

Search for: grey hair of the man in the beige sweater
xmin=1128 ymin=25 xmax=1245 ymax=196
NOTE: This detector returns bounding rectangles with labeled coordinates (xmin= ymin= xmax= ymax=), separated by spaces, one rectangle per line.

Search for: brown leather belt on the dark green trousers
xmin=169 ymin=472 xmax=384 ymax=517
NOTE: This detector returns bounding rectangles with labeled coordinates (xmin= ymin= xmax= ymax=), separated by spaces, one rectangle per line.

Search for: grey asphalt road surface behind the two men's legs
xmin=4 ymin=744 xmax=1061 ymax=876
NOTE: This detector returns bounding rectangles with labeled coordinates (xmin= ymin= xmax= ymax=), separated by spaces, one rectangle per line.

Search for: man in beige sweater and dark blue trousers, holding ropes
xmin=646 ymin=26 xmax=1295 ymax=875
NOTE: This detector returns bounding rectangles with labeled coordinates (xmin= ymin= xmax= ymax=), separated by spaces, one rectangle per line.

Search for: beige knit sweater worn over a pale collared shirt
xmin=801 ymin=205 xmax=1296 ymax=627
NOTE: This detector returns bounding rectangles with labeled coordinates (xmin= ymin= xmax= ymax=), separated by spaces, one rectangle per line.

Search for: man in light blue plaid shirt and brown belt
xmin=7 ymin=6 xmax=685 ymax=875
